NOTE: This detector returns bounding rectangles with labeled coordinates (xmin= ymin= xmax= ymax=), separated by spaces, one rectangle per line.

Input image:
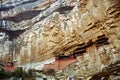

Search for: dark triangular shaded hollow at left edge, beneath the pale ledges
xmin=0 ymin=27 xmax=26 ymax=41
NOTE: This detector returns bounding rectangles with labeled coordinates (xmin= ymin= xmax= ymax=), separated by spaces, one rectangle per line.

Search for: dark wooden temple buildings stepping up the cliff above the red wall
xmin=57 ymin=34 xmax=109 ymax=60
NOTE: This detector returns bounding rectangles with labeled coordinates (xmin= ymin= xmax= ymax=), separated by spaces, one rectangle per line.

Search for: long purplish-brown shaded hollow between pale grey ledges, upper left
xmin=0 ymin=10 xmax=41 ymax=23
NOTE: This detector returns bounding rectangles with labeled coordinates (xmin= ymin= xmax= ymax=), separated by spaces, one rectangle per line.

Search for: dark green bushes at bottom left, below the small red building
xmin=0 ymin=68 xmax=42 ymax=80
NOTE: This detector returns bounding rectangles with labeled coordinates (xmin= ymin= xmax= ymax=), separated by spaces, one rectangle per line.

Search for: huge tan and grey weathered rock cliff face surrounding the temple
xmin=0 ymin=0 xmax=120 ymax=80
